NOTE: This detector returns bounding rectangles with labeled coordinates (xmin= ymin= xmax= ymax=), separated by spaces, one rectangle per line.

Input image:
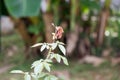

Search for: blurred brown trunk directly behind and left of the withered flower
xmin=42 ymin=0 xmax=54 ymax=42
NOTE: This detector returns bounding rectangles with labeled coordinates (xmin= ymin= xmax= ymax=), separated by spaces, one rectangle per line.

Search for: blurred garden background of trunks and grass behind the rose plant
xmin=0 ymin=0 xmax=120 ymax=80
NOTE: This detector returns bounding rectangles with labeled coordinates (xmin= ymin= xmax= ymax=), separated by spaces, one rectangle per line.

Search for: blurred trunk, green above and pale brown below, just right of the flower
xmin=66 ymin=0 xmax=80 ymax=56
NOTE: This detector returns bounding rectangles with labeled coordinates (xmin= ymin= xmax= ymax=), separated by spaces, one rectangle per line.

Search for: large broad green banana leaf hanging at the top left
xmin=4 ymin=0 xmax=41 ymax=18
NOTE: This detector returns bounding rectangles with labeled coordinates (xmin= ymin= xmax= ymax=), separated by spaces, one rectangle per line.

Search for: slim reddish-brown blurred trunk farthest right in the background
xmin=96 ymin=0 xmax=111 ymax=46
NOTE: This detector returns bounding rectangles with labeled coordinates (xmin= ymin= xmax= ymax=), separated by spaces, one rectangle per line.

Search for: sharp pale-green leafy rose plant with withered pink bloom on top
xmin=11 ymin=26 xmax=68 ymax=80
